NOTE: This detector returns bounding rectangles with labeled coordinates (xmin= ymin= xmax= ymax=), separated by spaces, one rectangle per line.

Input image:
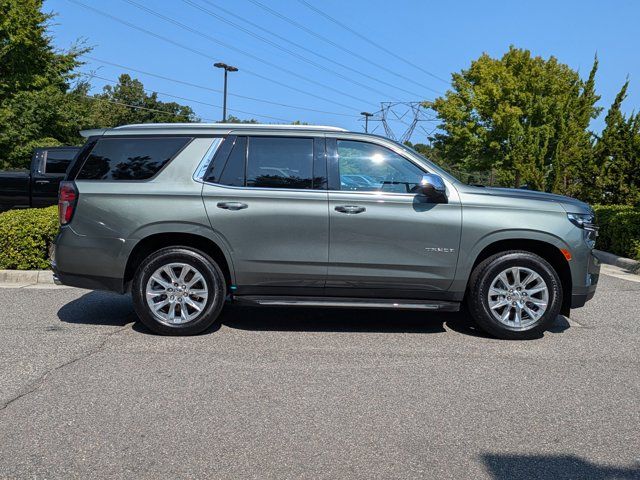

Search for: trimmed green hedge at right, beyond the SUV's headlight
xmin=594 ymin=205 xmax=640 ymax=258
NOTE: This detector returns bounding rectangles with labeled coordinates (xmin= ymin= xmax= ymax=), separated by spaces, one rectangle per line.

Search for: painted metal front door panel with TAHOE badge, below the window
xmin=327 ymin=192 xmax=462 ymax=291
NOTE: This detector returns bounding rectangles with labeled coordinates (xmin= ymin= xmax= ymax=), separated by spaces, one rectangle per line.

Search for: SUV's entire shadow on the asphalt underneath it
xmin=58 ymin=291 xmax=569 ymax=338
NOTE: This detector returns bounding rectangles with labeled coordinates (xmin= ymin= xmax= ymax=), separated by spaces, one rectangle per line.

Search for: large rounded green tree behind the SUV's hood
xmin=425 ymin=47 xmax=599 ymax=194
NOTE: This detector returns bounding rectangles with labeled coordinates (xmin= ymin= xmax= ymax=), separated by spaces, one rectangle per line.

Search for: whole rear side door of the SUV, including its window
xmin=202 ymin=136 xmax=329 ymax=288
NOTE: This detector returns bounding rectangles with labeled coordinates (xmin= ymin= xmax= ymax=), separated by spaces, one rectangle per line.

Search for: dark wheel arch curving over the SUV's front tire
xmin=465 ymin=238 xmax=573 ymax=316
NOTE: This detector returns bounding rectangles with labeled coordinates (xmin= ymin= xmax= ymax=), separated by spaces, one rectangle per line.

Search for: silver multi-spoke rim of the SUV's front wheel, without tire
xmin=488 ymin=267 xmax=549 ymax=329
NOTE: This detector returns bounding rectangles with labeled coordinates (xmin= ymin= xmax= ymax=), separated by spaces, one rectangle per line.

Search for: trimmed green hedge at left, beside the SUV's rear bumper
xmin=0 ymin=206 xmax=58 ymax=270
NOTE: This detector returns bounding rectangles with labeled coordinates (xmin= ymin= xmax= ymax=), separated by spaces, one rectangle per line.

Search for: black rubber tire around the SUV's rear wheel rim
xmin=131 ymin=247 xmax=227 ymax=335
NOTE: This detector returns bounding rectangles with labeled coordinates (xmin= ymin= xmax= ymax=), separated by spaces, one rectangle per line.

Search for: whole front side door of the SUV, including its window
xmin=327 ymin=139 xmax=462 ymax=290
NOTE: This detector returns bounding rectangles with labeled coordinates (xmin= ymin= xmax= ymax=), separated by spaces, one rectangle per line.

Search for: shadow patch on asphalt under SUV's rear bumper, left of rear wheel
xmin=58 ymin=291 xmax=138 ymax=326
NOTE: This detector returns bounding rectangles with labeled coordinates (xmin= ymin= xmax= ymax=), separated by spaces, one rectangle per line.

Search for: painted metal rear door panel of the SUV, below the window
xmin=202 ymin=185 xmax=329 ymax=288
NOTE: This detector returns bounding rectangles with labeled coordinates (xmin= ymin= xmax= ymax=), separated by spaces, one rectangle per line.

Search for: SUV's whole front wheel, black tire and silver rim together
xmin=467 ymin=251 xmax=562 ymax=340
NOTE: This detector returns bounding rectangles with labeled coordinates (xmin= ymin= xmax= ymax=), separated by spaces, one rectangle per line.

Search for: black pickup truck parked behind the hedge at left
xmin=0 ymin=147 xmax=80 ymax=212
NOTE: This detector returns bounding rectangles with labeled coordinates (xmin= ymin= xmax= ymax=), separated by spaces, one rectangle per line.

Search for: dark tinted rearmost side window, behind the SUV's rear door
xmin=77 ymin=137 xmax=191 ymax=180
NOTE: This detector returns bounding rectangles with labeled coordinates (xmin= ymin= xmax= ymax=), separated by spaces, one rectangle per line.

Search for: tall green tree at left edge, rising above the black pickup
xmin=0 ymin=0 xmax=85 ymax=167
